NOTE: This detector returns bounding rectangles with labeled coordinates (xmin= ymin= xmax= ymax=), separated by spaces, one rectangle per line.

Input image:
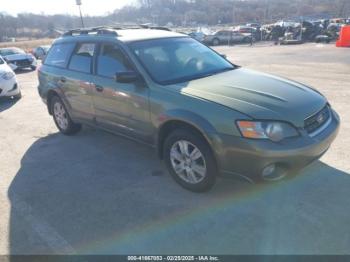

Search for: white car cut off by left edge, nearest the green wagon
xmin=0 ymin=56 xmax=22 ymax=99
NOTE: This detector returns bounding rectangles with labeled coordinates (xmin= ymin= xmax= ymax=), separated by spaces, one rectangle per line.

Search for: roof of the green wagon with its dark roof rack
xmin=55 ymin=29 xmax=188 ymax=43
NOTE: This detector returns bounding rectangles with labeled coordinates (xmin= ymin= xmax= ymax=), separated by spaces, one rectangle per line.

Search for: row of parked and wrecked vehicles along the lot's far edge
xmin=188 ymin=18 xmax=350 ymax=45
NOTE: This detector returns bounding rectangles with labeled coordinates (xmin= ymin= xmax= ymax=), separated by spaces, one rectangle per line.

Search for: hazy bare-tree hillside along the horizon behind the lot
xmin=0 ymin=0 xmax=350 ymax=40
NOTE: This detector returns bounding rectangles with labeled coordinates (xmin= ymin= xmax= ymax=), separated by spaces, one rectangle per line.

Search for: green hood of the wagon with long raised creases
xmin=177 ymin=68 xmax=327 ymax=127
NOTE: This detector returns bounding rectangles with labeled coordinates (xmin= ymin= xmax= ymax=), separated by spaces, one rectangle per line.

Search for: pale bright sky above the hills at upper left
xmin=0 ymin=0 xmax=134 ymax=16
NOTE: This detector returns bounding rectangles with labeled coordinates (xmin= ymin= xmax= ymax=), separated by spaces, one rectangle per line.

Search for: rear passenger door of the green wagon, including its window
xmin=64 ymin=43 xmax=96 ymax=122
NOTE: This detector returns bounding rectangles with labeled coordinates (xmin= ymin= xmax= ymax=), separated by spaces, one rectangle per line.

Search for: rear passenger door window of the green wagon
xmin=68 ymin=43 xmax=95 ymax=73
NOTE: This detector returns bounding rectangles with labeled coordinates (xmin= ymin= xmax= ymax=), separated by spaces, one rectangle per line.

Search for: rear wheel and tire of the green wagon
xmin=50 ymin=96 xmax=81 ymax=135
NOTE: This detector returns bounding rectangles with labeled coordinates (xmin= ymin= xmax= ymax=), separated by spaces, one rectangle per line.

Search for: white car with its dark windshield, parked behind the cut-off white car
xmin=0 ymin=47 xmax=37 ymax=70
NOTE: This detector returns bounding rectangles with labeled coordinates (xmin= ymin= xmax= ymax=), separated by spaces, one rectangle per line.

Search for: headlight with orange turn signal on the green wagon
xmin=237 ymin=121 xmax=299 ymax=142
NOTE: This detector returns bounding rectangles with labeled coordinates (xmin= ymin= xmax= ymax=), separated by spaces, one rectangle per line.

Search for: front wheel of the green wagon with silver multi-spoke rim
xmin=163 ymin=129 xmax=217 ymax=193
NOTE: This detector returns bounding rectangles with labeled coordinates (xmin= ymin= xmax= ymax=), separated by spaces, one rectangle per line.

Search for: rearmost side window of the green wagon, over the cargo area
xmin=44 ymin=43 xmax=74 ymax=67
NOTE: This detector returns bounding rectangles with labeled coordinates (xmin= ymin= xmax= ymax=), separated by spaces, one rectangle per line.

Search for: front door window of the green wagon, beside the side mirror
xmin=97 ymin=44 xmax=131 ymax=77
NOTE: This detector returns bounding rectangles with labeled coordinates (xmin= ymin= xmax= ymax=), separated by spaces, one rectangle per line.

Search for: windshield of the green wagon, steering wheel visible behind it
xmin=129 ymin=38 xmax=235 ymax=85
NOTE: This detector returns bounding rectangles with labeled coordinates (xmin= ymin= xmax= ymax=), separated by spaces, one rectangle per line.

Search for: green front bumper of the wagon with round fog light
xmin=215 ymin=110 xmax=340 ymax=181
